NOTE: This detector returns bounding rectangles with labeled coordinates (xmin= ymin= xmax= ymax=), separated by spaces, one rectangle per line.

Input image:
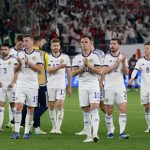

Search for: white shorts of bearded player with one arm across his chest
xmin=47 ymin=88 xmax=66 ymax=101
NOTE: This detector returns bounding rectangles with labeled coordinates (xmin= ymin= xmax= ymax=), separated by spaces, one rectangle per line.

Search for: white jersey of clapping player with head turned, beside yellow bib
xmin=17 ymin=50 xmax=43 ymax=88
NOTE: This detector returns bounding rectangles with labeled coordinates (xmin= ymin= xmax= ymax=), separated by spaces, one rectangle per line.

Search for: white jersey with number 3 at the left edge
xmin=0 ymin=55 xmax=18 ymax=89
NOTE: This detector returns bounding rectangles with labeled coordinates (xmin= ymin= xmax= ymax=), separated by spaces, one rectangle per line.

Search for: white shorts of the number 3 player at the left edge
xmin=0 ymin=88 xmax=15 ymax=103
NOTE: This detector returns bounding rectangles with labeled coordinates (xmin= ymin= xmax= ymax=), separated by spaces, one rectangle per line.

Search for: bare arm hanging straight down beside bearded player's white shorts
xmin=66 ymin=68 xmax=72 ymax=96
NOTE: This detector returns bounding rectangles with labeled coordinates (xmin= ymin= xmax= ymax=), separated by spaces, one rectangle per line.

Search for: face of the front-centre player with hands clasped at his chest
xmin=81 ymin=38 xmax=92 ymax=50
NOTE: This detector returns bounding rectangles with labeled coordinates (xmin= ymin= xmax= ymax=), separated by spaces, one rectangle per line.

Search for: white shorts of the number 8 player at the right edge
xmin=140 ymin=89 xmax=150 ymax=104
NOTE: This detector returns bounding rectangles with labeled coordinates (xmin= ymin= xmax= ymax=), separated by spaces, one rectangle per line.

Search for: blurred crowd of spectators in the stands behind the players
xmin=0 ymin=0 xmax=150 ymax=53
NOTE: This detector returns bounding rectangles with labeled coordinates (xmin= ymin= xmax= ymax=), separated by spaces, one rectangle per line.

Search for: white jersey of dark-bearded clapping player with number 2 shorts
xmin=104 ymin=53 xmax=128 ymax=90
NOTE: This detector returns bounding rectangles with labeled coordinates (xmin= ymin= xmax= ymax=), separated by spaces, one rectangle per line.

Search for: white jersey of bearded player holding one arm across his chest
xmin=47 ymin=53 xmax=71 ymax=89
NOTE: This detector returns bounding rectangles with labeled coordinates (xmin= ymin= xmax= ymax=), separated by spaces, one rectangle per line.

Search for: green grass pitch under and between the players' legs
xmin=0 ymin=88 xmax=150 ymax=150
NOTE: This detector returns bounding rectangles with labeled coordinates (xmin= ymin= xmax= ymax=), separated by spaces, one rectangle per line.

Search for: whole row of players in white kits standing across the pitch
xmin=0 ymin=35 xmax=150 ymax=143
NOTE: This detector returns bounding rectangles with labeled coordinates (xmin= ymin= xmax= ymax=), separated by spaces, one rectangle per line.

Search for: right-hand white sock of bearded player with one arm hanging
xmin=56 ymin=108 xmax=64 ymax=130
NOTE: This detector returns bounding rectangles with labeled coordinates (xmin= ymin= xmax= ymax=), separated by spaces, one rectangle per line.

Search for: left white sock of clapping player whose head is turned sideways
xmin=15 ymin=111 xmax=22 ymax=133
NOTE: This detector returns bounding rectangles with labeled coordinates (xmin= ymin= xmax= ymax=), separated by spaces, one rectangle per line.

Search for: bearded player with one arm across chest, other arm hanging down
xmin=47 ymin=38 xmax=72 ymax=134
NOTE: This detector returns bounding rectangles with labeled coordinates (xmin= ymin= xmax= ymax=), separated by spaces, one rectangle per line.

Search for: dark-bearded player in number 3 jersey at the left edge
xmin=0 ymin=44 xmax=18 ymax=131
